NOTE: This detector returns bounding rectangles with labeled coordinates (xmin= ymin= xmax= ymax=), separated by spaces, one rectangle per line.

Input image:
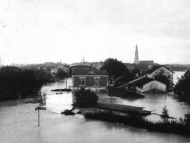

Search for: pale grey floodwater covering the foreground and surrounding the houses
xmin=0 ymin=72 xmax=190 ymax=143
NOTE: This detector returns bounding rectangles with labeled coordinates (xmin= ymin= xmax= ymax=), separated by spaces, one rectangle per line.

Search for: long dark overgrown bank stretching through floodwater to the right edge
xmin=84 ymin=111 xmax=190 ymax=136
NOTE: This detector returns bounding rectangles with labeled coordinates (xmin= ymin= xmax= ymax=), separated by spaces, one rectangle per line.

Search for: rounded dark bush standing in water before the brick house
xmin=74 ymin=88 xmax=98 ymax=107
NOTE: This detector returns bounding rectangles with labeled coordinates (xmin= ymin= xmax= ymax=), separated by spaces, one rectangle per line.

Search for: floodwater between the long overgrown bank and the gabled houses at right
xmin=100 ymin=94 xmax=190 ymax=120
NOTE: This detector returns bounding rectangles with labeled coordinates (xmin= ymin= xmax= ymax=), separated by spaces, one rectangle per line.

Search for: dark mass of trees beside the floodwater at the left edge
xmin=0 ymin=66 xmax=50 ymax=100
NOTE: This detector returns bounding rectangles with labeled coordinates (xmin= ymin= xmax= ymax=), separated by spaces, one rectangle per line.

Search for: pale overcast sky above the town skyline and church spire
xmin=0 ymin=0 xmax=190 ymax=64
